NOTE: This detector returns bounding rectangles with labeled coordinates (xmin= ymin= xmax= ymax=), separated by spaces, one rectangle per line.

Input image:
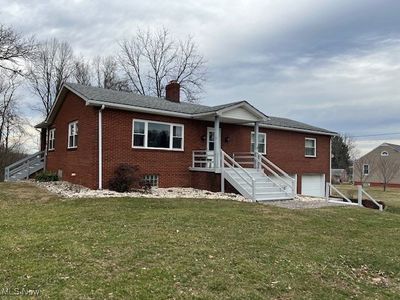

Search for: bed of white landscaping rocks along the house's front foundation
xmin=36 ymin=181 xmax=250 ymax=202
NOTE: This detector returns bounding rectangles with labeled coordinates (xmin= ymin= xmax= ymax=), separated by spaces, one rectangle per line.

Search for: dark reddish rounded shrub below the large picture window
xmin=109 ymin=164 xmax=139 ymax=193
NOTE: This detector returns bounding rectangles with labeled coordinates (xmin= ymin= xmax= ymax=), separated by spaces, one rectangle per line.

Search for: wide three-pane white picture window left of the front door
xmin=132 ymin=120 xmax=184 ymax=150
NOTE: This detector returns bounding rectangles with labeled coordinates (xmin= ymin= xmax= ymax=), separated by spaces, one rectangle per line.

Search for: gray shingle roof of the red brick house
xmin=65 ymin=83 xmax=335 ymax=134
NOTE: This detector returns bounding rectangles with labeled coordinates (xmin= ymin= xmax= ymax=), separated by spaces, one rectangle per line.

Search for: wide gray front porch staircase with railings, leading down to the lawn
xmin=221 ymin=151 xmax=296 ymax=201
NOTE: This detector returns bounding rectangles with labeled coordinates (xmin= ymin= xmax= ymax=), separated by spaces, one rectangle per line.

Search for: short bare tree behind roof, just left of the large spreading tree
xmin=93 ymin=56 xmax=130 ymax=91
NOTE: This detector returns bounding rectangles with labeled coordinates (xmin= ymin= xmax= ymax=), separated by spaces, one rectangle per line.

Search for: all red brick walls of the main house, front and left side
xmin=48 ymin=94 xmax=330 ymax=193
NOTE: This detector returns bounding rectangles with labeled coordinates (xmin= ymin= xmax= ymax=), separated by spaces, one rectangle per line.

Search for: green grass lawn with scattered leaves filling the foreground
xmin=0 ymin=183 xmax=400 ymax=299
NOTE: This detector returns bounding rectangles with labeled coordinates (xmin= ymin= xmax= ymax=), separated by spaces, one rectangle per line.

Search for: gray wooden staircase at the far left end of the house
xmin=4 ymin=151 xmax=44 ymax=181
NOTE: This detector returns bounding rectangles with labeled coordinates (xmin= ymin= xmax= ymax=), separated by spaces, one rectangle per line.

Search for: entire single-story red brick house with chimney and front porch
xmin=37 ymin=82 xmax=335 ymax=200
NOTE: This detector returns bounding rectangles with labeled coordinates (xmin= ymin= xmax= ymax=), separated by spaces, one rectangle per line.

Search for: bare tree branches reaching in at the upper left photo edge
xmin=0 ymin=24 xmax=35 ymax=74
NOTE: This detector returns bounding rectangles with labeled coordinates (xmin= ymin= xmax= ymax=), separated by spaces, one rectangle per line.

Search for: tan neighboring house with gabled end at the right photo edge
xmin=353 ymin=143 xmax=400 ymax=187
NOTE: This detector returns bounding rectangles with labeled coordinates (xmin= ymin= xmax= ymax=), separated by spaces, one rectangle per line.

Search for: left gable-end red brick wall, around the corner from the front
xmin=46 ymin=92 xmax=98 ymax=188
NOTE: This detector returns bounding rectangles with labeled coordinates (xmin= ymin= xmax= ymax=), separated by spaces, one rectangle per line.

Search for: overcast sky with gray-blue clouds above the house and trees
xmin=0 ymin=0 xmax=400 ymax=152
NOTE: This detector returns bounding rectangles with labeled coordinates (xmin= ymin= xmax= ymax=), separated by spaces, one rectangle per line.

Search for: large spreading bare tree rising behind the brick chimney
xmin=118 ymin=29 xmax=205 ymax=102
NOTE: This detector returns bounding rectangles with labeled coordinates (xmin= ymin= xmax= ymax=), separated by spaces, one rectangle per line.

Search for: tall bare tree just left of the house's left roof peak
xmin=28 ymin=39 xmax=73 ymax=117
